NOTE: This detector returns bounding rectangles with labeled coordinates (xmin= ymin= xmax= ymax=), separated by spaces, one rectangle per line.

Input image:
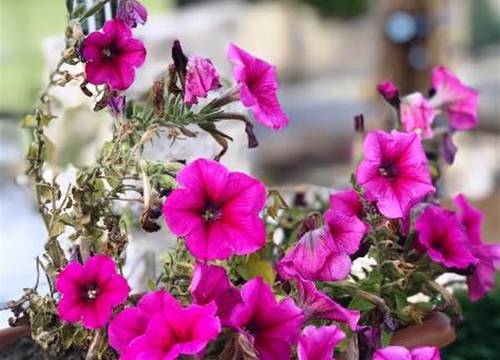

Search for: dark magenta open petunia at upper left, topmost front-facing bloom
xmin=81 ymin=20 xmax=146 ymax=90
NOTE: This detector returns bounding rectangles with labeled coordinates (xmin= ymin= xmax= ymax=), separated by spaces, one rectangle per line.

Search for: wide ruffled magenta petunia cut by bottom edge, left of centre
xmin=123 ymin=302 xmax=221 ymax=360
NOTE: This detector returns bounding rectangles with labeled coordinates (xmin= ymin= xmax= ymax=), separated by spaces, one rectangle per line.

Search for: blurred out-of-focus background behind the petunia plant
xmin=0 ymin=0 xmax=500 ymax=359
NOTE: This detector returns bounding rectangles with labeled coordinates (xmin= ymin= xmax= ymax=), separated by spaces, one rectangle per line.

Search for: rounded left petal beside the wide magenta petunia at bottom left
xmin=108 ymin=307 xmax=148 ymax=352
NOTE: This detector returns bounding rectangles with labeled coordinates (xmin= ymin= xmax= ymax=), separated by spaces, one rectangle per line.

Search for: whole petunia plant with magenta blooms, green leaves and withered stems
xmin=18 ymin=0 xmax=500 ymax=360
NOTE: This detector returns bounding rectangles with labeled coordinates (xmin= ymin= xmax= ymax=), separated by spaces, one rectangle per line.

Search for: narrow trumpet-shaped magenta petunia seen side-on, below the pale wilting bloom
xmin=296 ymin=280 xmax=360 ymax=331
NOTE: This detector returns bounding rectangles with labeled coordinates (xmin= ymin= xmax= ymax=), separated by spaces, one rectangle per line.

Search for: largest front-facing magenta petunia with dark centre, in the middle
xmin=163 ymin=159 xmax=266 ymax=260
